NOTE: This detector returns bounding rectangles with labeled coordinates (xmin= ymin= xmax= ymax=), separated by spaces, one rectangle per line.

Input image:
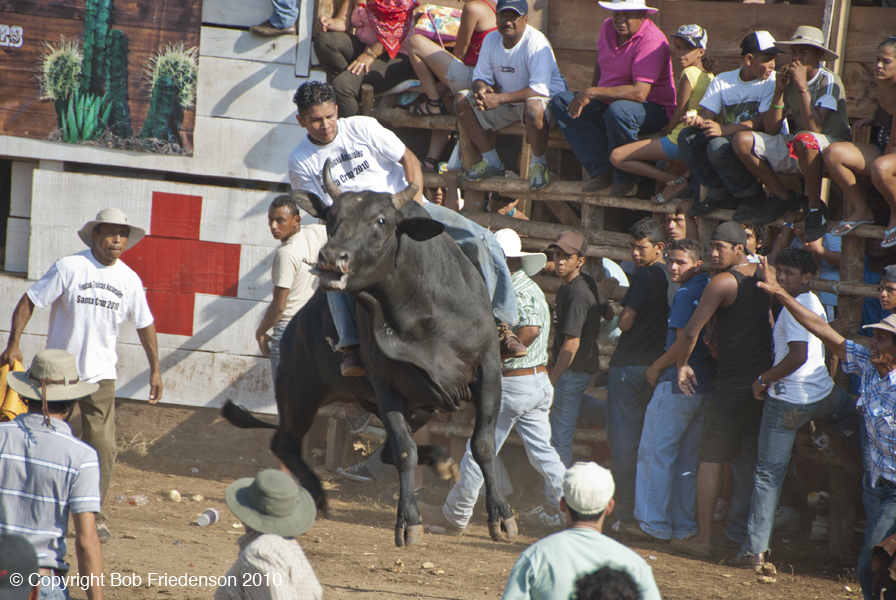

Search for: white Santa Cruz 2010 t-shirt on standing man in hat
xmin=26 ymin=249 xmax=153 ymax=383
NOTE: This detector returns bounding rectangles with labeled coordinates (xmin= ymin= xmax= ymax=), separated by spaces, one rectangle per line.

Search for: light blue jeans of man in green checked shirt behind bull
xmin=442 ymin=373 xmax=566 ymax=528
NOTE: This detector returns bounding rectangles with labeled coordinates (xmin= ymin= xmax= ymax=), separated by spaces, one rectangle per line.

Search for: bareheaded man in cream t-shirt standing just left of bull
xmin=255 ymin=194 xmax=327 ymax=383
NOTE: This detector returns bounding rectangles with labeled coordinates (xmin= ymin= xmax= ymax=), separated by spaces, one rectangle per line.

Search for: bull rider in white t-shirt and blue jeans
xmin=289 ymin=81 xmax=526 ymax=377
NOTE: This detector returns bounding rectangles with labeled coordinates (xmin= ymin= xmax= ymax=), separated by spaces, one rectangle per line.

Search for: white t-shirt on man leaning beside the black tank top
xmin=768 ymin=292 xmax=834 ymax=404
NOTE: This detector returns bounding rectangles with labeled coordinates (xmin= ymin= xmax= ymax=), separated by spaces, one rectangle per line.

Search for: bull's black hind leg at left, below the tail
xmin=271 ymin=378 xmax=330 ymax=516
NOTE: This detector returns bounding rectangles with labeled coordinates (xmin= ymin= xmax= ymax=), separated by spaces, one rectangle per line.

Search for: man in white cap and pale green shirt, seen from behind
xmin=503 ymin=462 xmax=660 ymax=600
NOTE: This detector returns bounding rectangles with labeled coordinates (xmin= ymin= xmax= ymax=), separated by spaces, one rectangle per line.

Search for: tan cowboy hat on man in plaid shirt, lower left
xmin=7 ymin=350 xmax=100 ymax=402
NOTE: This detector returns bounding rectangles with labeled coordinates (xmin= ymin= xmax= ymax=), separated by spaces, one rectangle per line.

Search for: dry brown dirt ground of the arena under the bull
xmin=57 ymin=401 xmax=861 ymax=600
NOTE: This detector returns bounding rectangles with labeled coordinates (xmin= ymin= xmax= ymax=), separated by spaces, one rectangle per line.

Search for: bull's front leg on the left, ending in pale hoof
xmin=376 ymin=381 xmax=423 ymax=547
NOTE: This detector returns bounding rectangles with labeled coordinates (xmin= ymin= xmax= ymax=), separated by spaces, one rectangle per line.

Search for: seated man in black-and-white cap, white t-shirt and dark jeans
xmin=678 ymin=31 xmax=778 ymax=221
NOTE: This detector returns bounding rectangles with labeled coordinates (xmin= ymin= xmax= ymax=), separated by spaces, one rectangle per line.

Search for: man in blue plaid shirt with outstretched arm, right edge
xmin=759 ymin=258 xmax=896 ymax=600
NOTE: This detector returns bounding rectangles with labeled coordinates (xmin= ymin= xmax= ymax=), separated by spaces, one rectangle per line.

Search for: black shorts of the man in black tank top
xmin=698 ymin=386 xmax=762 ymax=464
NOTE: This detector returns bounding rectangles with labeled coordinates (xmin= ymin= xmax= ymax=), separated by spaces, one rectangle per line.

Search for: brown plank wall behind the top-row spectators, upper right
xmin=547 ymin=0 xmax=880 ymax=118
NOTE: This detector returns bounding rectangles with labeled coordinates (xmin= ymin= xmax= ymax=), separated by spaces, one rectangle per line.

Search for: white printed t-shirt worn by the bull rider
xmin=288 ymin=117 xmax=408 ymax=205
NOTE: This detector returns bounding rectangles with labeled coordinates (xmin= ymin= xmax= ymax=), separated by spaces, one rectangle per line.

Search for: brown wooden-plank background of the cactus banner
xmin=0 ymin=0 xmax=202 ymax=139
